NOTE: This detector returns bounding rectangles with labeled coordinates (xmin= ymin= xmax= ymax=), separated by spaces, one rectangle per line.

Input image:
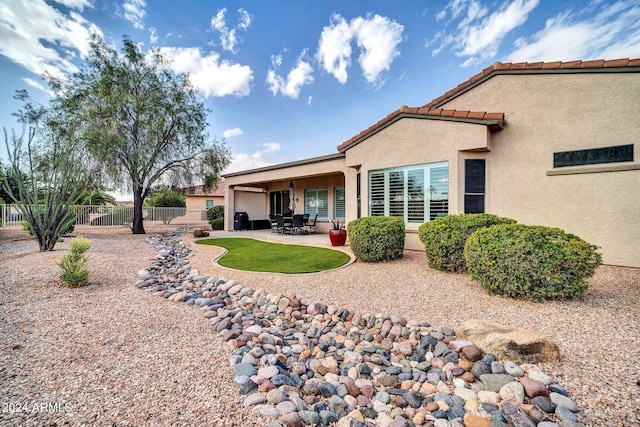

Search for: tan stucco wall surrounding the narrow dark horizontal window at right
xmin=442 ymin=73 xmax=640 ymax=267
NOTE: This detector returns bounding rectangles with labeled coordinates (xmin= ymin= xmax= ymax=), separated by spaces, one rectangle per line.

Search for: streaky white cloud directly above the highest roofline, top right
xmin=507 ymin=2 xmax=640 ymax=62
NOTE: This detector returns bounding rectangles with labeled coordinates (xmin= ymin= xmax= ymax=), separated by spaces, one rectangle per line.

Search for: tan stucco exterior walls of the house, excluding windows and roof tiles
xmin=226 ymin=60 xmax=640 ymax=267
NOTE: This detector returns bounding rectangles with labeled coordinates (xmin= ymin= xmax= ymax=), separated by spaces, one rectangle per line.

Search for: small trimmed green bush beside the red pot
xmin=347 ymin=216 xmax=404 ymax=262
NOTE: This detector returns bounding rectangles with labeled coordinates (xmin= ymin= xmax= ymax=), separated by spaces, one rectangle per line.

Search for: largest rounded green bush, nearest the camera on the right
xmin=464 ymin=224 xmax=602 ymax=301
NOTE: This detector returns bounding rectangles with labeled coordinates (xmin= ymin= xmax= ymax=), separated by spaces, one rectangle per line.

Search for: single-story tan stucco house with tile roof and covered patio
xmin=224 ymin=59 xmax=640 ymax=267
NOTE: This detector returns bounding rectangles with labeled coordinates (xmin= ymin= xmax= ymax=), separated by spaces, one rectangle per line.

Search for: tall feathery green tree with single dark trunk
xmin=48 ymin=34 xmax=230 ymax=234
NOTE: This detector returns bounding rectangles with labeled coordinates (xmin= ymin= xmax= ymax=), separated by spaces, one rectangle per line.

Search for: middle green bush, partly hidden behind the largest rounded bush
xmin=418 ymin=214 xmax=516 ymax=273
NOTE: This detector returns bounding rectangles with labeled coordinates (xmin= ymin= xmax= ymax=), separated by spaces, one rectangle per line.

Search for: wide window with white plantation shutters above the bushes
xmin=369 ymin=162 xmax=449 ymax=225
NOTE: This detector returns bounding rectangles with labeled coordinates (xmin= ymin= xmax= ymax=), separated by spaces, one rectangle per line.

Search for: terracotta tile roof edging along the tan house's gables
xmin=338 ymin=58 xmax=640 ymax=152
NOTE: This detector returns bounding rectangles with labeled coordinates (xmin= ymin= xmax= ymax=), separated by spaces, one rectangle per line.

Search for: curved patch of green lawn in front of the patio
xmin=196 ymin=238 xmax=350 ymax=274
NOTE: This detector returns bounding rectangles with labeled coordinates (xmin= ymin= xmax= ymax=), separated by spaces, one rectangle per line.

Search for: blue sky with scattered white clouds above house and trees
xmin=0 ymin=0 xmax=640 ymax=194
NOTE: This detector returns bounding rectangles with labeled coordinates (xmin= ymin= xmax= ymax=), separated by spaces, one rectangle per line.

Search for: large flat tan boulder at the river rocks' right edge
xmin=455 ymin=319 xmax=560 ymax=363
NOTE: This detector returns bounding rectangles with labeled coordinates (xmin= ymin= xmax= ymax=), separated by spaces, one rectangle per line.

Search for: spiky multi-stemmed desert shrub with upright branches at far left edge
xmin=3 ymin=91 xmax=91 ymax=252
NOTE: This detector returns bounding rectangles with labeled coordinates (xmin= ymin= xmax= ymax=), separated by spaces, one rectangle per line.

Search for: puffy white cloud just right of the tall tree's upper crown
xmin=160 ymin=47 xmax=253 ymax=98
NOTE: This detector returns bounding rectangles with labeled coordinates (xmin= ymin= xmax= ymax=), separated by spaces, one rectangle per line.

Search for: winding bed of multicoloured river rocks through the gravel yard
xmin=136 ymin=231 xmax=582 ymax=427
